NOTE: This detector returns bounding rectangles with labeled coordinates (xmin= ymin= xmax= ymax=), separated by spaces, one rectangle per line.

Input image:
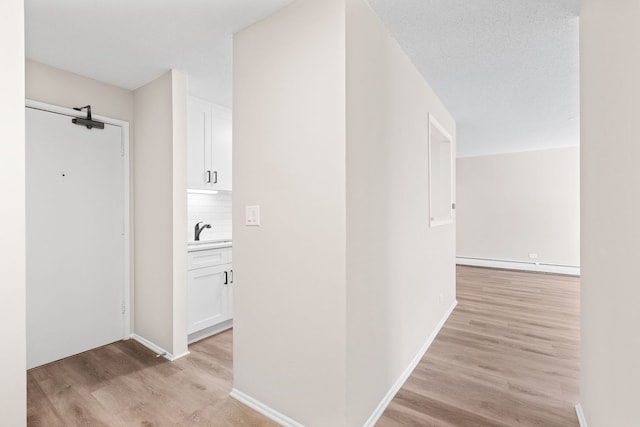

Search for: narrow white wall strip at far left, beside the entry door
xmin=0 ymin=0 xmax=27 ymax=427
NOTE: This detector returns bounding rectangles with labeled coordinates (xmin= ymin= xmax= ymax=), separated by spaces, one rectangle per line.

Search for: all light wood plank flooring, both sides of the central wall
xmin=27 ymin=267 xmax=579 ymax=427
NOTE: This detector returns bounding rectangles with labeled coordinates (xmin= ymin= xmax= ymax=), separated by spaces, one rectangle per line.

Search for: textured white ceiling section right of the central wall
xmin=369 ymin=0 xmax=580 ymax=157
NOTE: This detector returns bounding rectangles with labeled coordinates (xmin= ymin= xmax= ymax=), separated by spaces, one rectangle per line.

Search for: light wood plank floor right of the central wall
xmin=377 ymin=266 xmax=580 ymax=427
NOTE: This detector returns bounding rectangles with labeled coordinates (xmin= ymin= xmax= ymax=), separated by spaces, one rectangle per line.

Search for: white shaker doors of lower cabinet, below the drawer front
xmin=188 ymin=264 xmax=231 ymax=333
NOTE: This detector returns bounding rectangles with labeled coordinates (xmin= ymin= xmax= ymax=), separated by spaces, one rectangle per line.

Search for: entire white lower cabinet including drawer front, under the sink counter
xmin=187 ymin=248 xmax=233 ymax=342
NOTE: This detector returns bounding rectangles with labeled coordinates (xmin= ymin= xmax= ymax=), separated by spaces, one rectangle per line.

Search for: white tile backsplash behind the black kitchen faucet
xmin=187 ymin=193 xmax=231 ymax=242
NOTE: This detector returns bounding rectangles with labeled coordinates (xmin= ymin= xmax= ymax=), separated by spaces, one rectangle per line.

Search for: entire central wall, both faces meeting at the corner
xmin=233 ymin=0 xmax=455 ymax=427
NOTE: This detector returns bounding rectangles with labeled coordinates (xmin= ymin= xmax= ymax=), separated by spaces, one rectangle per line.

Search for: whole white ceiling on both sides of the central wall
xmin=25 ymin=0 xmax=579 ymax=156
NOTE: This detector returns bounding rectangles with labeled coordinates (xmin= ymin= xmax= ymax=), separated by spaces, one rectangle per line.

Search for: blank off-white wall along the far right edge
xmin=580 ymin=0 xmax=640 ymax=427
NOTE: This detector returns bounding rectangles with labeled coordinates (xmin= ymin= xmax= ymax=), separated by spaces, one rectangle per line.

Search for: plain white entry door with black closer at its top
xmin=26 ymin=108 xmax=125 ymax=368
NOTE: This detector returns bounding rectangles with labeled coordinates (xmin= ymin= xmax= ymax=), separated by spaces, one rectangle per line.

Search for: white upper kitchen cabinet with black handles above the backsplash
xmin=187 ymin=97 xmax=232 ymax=191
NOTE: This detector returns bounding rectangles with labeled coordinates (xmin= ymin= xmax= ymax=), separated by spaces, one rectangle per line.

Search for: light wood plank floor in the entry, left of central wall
xmin=27 ymin=331 xmax=277 ymax=427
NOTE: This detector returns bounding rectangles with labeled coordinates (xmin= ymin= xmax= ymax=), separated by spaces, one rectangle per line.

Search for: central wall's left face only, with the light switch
xmin=233 ymin=0 xmax=346 ymax=427
